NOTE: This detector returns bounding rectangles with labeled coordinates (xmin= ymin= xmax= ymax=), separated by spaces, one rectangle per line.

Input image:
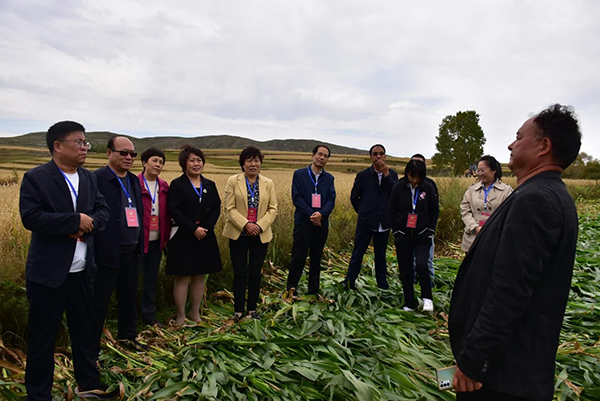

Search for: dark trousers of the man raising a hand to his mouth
xmin=346 ymin=227 xmax=390 ymax=288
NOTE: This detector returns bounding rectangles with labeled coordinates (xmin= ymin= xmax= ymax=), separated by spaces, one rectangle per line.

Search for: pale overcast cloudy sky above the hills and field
xmin=0 ymin=0 xmax=600 ymax=162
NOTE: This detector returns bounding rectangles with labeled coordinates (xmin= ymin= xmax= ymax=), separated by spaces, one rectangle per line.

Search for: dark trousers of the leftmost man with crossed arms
xmin=25 ymin=271 xmax=100 ymax=400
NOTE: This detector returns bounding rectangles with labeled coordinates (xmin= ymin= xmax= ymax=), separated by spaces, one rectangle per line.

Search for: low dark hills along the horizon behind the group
xmin=0 ymin=132 xmax=366 ymax=155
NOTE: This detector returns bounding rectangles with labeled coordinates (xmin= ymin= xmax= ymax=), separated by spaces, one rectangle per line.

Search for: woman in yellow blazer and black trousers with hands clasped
xmin=223 ymin=146 xmax=277 ymax=322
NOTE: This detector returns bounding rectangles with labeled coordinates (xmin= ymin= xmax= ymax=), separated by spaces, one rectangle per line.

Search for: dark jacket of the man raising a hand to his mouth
xmin=350 ymin=166 xmax=398 ymax=231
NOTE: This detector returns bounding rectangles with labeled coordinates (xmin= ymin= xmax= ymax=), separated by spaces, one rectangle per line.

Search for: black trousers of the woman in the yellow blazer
xmin=229 ymin=236 xmax=269 ymax=313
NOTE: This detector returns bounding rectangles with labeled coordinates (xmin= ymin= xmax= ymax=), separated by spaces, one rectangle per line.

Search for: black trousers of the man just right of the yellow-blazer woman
xmin=287 ymin=225 xmax=329 ymax=294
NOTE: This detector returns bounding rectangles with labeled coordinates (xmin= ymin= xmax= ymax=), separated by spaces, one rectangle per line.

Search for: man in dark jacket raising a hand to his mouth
xmin=344 ymin=144 xmax=398 ymax=289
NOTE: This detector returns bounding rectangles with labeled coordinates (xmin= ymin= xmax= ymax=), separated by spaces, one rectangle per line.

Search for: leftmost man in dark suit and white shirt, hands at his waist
xmin=19 ymin=121 xmax=119 ymax=400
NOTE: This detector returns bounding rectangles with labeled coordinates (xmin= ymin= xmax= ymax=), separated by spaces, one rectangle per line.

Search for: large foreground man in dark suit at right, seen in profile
xmin=449 ymin=104 xmax=581 ymax=401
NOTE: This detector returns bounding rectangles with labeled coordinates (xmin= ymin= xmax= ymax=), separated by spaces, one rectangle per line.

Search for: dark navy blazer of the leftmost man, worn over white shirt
xmin=19 ymin=161 xmax=110 ymax=288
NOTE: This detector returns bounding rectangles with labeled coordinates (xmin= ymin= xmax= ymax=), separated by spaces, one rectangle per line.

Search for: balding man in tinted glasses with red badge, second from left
xmin=94 ymin=136 xmax=144 ymax=353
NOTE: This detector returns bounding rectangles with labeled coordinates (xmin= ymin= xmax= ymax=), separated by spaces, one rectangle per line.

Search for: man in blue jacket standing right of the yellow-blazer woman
xmin=287 ymin=145 xmax=335 ymax=297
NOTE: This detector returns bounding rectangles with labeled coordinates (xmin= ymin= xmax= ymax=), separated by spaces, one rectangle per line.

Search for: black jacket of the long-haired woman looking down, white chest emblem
xmin=389 ymin=177 xmax=440 ymax=240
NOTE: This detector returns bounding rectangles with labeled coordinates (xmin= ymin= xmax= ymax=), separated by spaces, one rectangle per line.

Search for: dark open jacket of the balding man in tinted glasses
xmin=94 ymin=166 xmax=144 ymax=269
